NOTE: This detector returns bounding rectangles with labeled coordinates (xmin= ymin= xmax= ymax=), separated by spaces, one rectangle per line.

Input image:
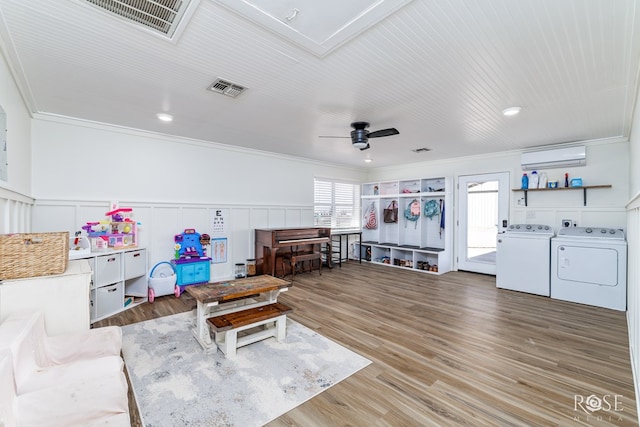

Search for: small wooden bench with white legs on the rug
xmin=207 ymin=302 xmax=293 ymax=358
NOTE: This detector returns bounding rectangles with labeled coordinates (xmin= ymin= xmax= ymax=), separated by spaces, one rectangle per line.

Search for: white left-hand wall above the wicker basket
xmin=0 ymin=41 xmax=33 ymax=234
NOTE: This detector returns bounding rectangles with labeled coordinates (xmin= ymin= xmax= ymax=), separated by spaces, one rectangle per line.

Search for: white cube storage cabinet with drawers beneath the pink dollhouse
xmin=77 ymin=248 xmax=148 ymax=323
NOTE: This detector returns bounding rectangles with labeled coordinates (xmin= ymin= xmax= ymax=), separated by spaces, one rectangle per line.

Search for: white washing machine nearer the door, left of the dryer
xmin=496 ymin=224 xmax=555 ymax=297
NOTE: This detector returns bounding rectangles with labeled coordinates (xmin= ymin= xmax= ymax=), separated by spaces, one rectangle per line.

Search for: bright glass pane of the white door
xmin=467 ymin=181 xmax=499 ymax=264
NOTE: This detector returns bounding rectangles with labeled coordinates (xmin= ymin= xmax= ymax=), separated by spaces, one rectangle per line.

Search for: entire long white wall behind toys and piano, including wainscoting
xmin=32 ymin=115 xmax=365 ymax=278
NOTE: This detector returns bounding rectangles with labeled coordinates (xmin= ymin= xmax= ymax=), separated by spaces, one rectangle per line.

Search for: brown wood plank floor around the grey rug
xmin=94 ymin=262 xmax=638 ymax=427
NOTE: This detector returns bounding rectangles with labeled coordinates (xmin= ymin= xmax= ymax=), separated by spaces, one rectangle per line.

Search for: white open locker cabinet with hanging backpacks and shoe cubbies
xmin=360 ymin=177 xmax=453 ymax=274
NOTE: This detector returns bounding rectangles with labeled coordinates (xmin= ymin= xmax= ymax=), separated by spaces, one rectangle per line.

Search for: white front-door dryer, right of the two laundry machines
xmin=551 ymin=227 xmax=627 ymax=311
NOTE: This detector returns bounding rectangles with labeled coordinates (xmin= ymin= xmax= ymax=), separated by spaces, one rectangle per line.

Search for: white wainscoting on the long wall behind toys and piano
xmin=32 ymin=199 xmax=313 ymax=280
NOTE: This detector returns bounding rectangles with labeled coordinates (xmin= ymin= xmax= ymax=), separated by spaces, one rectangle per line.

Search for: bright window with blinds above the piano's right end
xmin=313 ymin=178 xmax=360 ymax=229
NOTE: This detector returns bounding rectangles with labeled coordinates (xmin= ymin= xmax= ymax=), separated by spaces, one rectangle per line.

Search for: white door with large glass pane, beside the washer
xmin=457 ymin=172 xmax=510 ymax=275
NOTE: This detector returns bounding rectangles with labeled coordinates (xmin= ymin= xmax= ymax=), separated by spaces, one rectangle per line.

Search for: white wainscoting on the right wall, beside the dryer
xmin=627 ymin=194 xmax=640 ymax=413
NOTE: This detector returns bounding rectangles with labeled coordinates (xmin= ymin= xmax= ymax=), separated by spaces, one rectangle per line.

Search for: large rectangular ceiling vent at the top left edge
xmin=86 ymin=0 xmax=199 ymax=39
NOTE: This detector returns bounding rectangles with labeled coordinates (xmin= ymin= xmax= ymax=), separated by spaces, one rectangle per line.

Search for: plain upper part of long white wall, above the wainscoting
xmin=32 ymin=115 xmax=363 ymax=206
